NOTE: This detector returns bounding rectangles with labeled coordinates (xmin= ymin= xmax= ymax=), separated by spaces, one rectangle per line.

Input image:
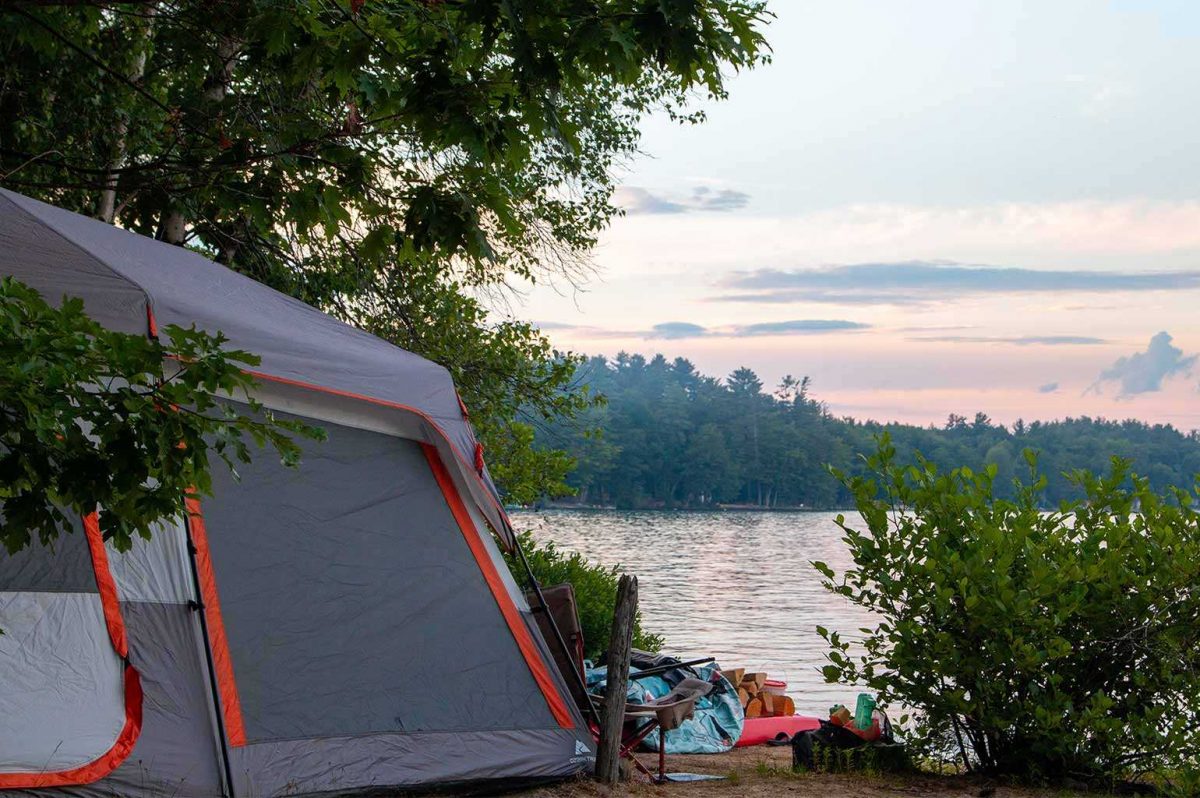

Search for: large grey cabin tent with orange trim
xmin=0 ymin=191 xmax=594 ymax=798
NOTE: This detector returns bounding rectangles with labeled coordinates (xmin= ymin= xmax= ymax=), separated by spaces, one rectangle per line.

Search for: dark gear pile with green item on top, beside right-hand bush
xmin=792 ymin=692 xmax=908 ymax=773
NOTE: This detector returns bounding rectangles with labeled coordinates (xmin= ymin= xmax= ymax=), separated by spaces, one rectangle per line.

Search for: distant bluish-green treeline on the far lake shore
xmin=536 ymin=353 xmax=1200 ymax=508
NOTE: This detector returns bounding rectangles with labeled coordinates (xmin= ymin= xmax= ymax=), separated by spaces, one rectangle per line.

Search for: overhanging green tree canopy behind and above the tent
xmin=0 ymin=0 xmax=768 ymax=497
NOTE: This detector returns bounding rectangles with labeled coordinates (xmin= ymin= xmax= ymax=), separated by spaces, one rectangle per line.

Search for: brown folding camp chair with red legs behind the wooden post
xmin=527 ymin=583 xmax=713 ymax=782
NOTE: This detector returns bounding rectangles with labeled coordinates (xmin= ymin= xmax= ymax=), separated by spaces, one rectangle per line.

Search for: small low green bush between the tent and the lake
xmin=508 ymin=532 xmax=662 ymax=660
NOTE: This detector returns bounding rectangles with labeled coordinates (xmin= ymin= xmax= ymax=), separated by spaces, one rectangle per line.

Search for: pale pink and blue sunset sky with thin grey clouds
xmin=515 ymin=0 xmax=1200 ymax=430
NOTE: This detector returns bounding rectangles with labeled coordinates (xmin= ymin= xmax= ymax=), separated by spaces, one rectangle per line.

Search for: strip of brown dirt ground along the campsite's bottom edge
xmin=496 ymin=746 xmax=1081 ymax=798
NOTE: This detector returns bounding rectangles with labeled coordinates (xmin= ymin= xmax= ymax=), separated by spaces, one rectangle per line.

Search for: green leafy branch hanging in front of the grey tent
xmin=0 ymin=277 xmax=324 ymax=553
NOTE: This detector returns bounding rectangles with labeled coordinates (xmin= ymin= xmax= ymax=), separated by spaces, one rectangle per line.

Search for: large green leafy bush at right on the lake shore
xmin=815 ymin=436 xmax=1200 ymax=780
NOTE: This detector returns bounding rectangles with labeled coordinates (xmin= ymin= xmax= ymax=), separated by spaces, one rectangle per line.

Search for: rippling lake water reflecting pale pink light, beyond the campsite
xmin=512 ymin=510 xmax=874 ymax=716
